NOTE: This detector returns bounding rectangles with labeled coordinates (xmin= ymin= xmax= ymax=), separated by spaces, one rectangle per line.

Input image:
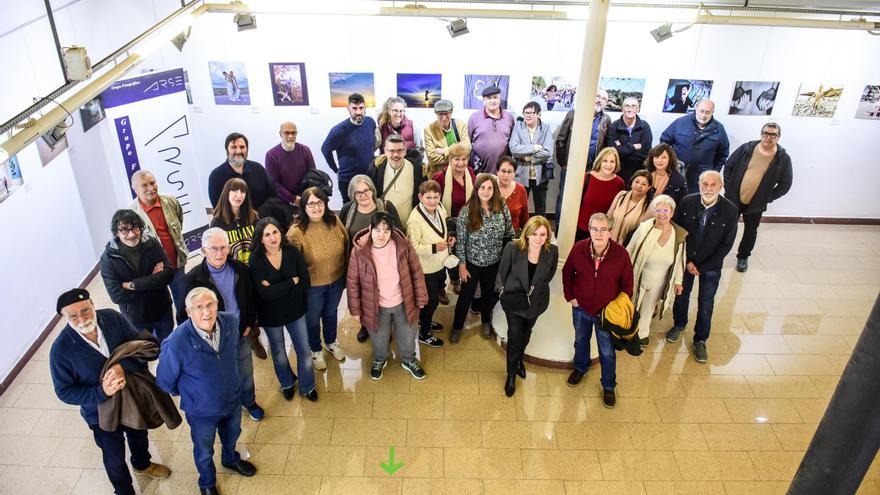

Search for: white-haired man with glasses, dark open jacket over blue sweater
xmin=186 ymin=227 xmax=265 ymax=421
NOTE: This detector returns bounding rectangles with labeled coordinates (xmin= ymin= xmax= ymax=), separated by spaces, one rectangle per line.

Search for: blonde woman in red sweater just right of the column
xmin=575 ymin=146 xmax=626 ymax=241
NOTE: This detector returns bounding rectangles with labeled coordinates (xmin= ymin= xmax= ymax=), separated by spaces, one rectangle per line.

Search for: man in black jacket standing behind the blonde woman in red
xmin=605 ymin=96 xmax=654 ymax=184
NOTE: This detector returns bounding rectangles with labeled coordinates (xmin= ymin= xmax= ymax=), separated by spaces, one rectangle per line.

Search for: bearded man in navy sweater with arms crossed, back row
xmin=321 ymin=93 xmax=378 ymax=204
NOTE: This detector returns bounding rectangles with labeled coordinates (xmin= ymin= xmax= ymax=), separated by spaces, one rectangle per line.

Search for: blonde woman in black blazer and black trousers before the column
xmin=498 ymin=215 xmax=559 ymax=397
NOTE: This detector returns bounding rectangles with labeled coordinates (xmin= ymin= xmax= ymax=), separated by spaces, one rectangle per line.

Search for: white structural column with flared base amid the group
xmin=492 ymin=0 xmax=610 ymax=365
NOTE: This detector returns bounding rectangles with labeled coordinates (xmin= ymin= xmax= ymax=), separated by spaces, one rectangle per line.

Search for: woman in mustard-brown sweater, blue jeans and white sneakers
xmin=287 ymin=187 xmax=348 ymax=371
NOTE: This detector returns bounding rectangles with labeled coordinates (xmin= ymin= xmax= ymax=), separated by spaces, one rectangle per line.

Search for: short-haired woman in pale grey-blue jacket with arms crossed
xmin=508 ymin=101 xmax=555 ymax=215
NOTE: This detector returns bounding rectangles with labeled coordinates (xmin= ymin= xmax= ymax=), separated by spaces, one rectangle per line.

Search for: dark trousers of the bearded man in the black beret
xmin=89 ymin=425 xmax=151 ymax=495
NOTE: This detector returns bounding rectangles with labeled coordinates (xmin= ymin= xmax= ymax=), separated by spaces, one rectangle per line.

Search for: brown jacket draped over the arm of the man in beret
xmin=98 ymin=339 xmax=182 ymax=431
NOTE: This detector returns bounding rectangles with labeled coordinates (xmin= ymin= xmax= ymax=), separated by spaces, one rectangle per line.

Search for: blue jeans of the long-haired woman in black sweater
xmin=263 ymin=316 xmax=315 ymax=395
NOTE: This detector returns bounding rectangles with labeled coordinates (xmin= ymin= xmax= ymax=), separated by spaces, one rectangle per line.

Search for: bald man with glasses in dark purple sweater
xmin=266 ymin=122 xmax=315 ymax=206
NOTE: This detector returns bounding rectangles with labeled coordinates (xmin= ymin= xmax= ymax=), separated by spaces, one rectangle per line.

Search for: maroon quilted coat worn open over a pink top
xmin=345 ymin=228 xmax=428 ymax=332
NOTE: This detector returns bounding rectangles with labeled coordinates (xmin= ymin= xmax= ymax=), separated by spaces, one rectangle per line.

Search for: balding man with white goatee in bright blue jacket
xmin=660 ymin=99 xmax=730 ymax=194
